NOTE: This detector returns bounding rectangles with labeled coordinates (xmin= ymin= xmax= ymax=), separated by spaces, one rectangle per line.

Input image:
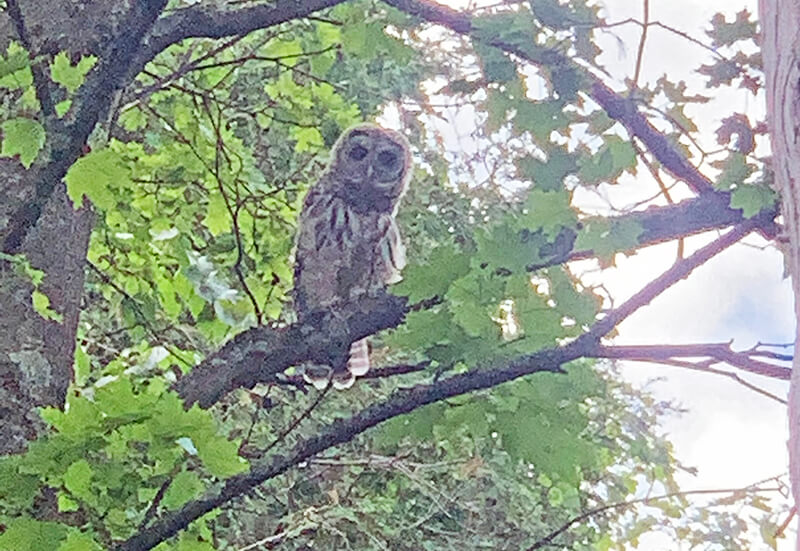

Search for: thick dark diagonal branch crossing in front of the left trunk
xmin=2 ymin=0 xmax=166 ymax=253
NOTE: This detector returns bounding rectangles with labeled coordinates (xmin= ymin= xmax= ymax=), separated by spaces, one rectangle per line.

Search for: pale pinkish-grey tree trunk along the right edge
xmin=758 ymin=0 xmax=800 ymax=550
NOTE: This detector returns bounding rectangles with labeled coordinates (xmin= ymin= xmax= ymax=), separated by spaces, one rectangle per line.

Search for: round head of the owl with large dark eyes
xmin=329 ymin=124 xmax=411 ymax=211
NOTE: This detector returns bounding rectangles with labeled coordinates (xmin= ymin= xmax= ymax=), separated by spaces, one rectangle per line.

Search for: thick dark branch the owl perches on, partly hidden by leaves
xmin=175 ymin=194 xmax=771 ymax=408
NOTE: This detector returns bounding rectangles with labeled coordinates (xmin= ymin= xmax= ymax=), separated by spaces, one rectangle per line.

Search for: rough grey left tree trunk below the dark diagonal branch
xmin=0 ymin=167 xmax=92 ymax=454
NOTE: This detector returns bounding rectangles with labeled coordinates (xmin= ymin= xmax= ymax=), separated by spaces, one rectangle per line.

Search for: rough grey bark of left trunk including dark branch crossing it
xmin=0 ymin=0 xmax=166 ymax=454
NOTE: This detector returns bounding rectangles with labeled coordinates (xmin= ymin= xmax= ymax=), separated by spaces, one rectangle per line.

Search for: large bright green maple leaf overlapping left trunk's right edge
xmin=64 ymin=148 xmax=131 ymax=209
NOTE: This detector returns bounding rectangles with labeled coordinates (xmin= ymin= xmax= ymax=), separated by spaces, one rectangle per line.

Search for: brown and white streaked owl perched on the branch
xmin=294 ymin=124 xmax=411 ymax=388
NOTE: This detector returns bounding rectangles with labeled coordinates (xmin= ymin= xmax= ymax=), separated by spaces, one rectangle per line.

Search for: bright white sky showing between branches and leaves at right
xmin=432 ymin=0 xmax=796 ymax=551
